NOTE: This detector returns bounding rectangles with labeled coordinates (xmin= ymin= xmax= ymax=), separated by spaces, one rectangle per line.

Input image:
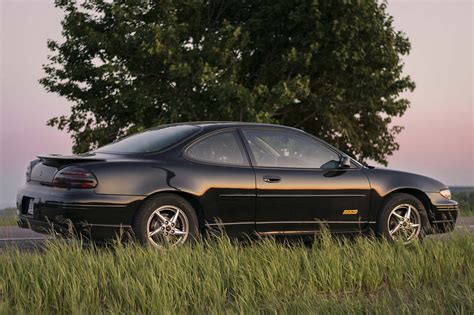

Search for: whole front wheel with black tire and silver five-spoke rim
xmin=377 ymin=193 xmax=428 ymax=245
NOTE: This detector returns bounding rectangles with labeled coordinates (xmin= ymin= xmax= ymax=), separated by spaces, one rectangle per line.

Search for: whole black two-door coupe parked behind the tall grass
xmin=17 ymin=122 xmax=458 ymax=246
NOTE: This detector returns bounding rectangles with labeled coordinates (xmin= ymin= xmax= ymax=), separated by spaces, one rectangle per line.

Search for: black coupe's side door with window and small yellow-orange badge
xmin=242 ymin=128 xmax=370 ymax=234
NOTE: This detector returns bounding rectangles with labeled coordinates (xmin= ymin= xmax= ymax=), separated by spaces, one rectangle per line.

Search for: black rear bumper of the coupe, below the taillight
xmin=16 ymin=182 xmax=145 ymax=239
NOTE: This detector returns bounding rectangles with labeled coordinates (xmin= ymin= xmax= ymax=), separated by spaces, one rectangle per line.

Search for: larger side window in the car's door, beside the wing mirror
xmin=244 ymin=129 xmax=339 ymax=168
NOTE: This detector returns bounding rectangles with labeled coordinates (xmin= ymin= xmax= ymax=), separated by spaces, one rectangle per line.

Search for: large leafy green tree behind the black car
xmin=40 ymin=0 xmax=415 ymax=164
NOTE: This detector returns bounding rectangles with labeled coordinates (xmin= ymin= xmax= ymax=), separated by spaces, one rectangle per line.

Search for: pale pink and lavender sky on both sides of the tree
xmin=0 ymin=0 xmax=474 ymax=207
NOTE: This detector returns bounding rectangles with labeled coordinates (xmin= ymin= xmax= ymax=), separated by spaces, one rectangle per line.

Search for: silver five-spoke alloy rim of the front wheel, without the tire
xmin=388 ymin=204 xmax=421 ymax=244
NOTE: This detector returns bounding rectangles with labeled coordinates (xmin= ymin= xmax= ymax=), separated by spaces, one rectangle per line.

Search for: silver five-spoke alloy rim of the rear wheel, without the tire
xmin=147 ymin=205 xmax=189 ymax=247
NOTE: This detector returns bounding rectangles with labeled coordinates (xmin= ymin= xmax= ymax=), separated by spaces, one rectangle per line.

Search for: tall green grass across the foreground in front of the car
xmin=0 ymin=233 xmax=474 ymax=314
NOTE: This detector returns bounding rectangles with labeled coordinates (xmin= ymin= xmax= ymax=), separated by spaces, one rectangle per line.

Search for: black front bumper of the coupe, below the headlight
xmin=427 ymin=192 xmax=459 ymax=233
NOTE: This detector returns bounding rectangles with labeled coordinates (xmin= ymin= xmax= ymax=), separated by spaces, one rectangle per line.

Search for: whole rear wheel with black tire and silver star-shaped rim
xmin=132 ymin=194 xmax=199 ymax=247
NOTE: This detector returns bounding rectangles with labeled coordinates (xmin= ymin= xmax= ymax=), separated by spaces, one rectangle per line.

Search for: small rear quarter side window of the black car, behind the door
xmin=186 ymin=131 xmax=248 ymax=165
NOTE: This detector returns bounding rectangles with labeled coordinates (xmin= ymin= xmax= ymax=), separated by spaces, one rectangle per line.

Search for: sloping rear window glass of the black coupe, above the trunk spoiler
xmin=95 ymin=125 xmax=200 ymax=154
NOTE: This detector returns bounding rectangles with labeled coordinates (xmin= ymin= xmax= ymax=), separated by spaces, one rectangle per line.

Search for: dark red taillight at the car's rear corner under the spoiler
xmin=53 ymin=166 xmax=97 ymax=189
